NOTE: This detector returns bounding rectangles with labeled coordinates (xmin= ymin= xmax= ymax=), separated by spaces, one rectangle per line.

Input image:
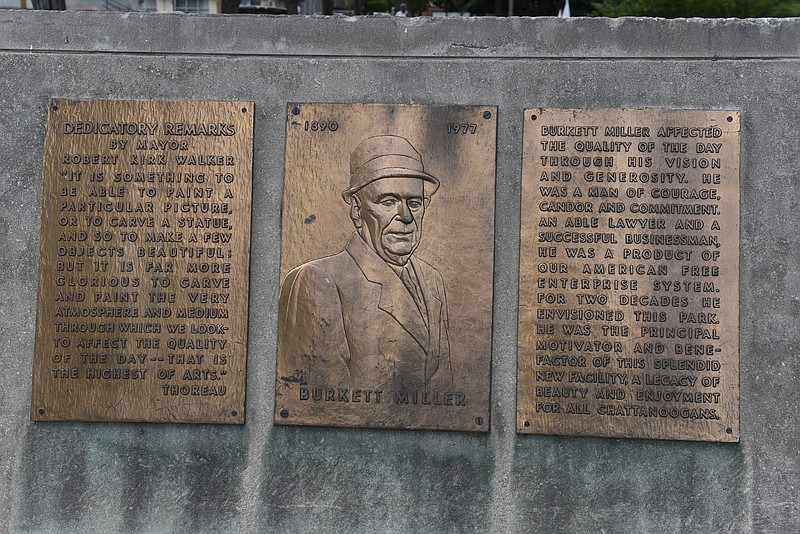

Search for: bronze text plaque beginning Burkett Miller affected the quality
xmin=517 ymin=109 xmax=739 ymax=441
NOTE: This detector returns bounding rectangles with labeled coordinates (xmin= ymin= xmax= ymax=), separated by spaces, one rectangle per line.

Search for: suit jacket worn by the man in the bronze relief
xmin=278 ymin=233 xmax=453 ymax=391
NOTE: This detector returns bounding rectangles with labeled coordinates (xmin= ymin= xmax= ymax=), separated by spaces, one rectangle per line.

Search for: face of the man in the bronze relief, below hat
xmin=350 ymin=178 xmax=430 ymax=266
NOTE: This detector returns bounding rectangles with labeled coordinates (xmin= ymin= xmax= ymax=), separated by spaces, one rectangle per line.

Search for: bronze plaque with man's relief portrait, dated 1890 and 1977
xmin=275 ymin=104 xmax=496 ymax=432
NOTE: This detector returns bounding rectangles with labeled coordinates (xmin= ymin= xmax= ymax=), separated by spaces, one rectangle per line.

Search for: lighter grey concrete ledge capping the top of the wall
xmin=0 ymin=11 xmax=800 ymax=59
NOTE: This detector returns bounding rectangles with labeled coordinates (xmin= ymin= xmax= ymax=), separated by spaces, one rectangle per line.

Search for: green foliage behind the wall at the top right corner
xmin=591 ymin=0 xmax=800 ymax=19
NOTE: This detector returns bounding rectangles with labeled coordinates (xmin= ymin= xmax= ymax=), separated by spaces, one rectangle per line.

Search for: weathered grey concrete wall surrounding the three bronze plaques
xmin=0 ymin=12 xmax=800 ymax=533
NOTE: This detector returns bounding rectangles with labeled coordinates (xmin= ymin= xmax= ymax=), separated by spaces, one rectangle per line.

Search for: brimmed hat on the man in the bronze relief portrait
xmin=342 ymin=135 xmax=439 ymax=204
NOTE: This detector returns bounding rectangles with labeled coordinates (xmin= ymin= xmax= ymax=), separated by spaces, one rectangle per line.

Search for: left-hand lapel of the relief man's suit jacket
xmin=345 ymin=233 xmax=432 ymax=352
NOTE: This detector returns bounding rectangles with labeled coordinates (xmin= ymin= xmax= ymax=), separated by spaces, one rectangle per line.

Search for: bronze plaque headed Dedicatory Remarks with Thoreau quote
xmin=31 ymin=100 xmax=253 ymax=424
